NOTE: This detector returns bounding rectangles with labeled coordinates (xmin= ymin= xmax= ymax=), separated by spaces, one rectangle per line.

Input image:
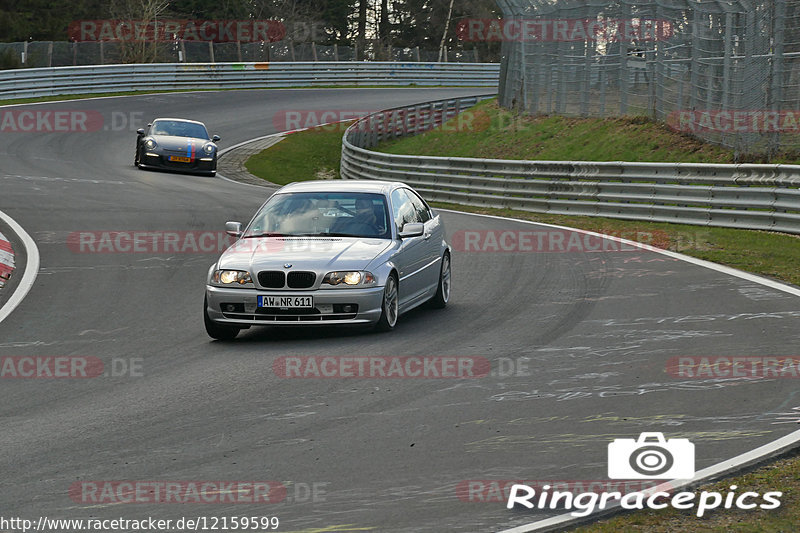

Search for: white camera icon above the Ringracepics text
xmin=608 ymin=433 xmax=694 ymax=479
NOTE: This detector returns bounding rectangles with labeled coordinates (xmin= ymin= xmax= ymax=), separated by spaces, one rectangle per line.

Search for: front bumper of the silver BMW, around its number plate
xmin=206 ymin=285 xmax=383 ymax=326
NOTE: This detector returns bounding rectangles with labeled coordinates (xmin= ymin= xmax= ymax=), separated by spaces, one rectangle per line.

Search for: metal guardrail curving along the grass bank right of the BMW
xmin=341 ymin=95 xmax=800 ymax=234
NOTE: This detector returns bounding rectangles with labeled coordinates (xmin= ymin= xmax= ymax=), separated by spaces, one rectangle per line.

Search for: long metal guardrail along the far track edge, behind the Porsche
xmin=0 ymin=61 xmax=500 ymax=101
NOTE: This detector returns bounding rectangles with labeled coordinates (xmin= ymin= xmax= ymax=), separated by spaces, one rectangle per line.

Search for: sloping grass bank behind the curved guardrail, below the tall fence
xmin=376 ymin=100 xmax=800 ymax=164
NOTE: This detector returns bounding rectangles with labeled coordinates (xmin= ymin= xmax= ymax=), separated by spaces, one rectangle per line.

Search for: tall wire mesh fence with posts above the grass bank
xmin=496 ymin=0 xmax=800 ymax=156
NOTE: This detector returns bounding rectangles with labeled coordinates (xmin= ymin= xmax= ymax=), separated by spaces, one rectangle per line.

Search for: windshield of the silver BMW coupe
xmin=244 ymin=192 xmax=391 ymax=239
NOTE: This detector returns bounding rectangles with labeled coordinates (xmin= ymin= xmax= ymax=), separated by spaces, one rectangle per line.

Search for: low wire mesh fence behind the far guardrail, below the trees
xmin=0 ymin=41 xmax=485 ymax=70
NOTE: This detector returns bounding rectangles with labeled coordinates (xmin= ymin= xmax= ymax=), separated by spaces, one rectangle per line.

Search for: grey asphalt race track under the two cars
xmin=0 ymin=89 xmax=800 ymax=533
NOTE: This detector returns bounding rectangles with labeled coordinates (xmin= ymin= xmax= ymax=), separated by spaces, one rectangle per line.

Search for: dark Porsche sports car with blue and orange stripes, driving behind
xmin=133 ymin=118 xmax=219 ymax=176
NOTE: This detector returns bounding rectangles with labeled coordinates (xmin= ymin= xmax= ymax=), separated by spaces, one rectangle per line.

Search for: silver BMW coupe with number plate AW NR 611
xmin=203 ymin=181 xmax=450 ymax=340
